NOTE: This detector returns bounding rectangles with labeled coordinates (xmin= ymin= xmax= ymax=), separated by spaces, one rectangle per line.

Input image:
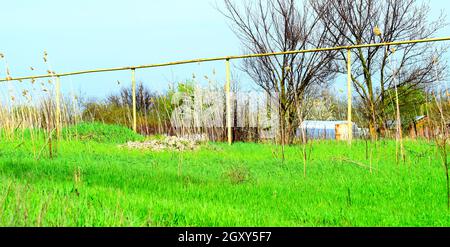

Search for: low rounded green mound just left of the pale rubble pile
xmin=63 ymin=122 xmax=144 ymax=143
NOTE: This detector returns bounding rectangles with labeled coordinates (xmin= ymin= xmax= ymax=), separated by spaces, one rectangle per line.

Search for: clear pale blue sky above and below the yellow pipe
xmin=0 ymin=0 xmax=450 ymax=102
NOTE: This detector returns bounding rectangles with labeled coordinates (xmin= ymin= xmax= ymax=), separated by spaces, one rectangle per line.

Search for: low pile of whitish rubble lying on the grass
xmin=121 ymin=135 xmax=208 ymax=151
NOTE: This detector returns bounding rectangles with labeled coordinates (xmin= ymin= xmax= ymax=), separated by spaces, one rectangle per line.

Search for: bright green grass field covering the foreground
xmin=0 ymin=123 xmax=450 ymax=226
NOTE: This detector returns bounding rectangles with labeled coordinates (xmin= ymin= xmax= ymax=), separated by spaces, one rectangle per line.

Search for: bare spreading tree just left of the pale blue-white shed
xmin=221 ymin=0 xmax=337 ymax=144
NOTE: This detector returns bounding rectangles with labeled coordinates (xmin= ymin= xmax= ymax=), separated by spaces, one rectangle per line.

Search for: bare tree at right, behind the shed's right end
xmin=310 ymin=0 xmax=446 ymax=138
